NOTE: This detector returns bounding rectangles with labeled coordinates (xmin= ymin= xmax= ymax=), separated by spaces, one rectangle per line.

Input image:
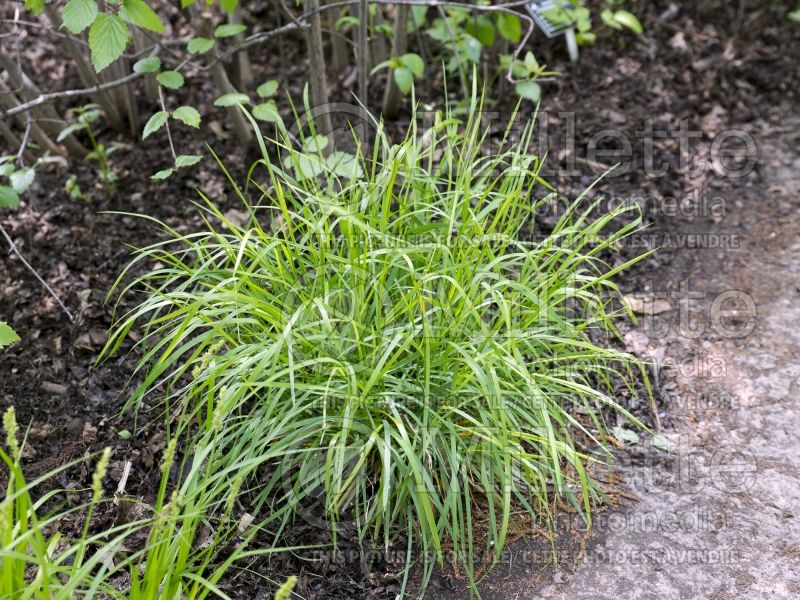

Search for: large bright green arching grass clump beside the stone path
xmin=106 ymin=90 xmax=644 ymax=590
